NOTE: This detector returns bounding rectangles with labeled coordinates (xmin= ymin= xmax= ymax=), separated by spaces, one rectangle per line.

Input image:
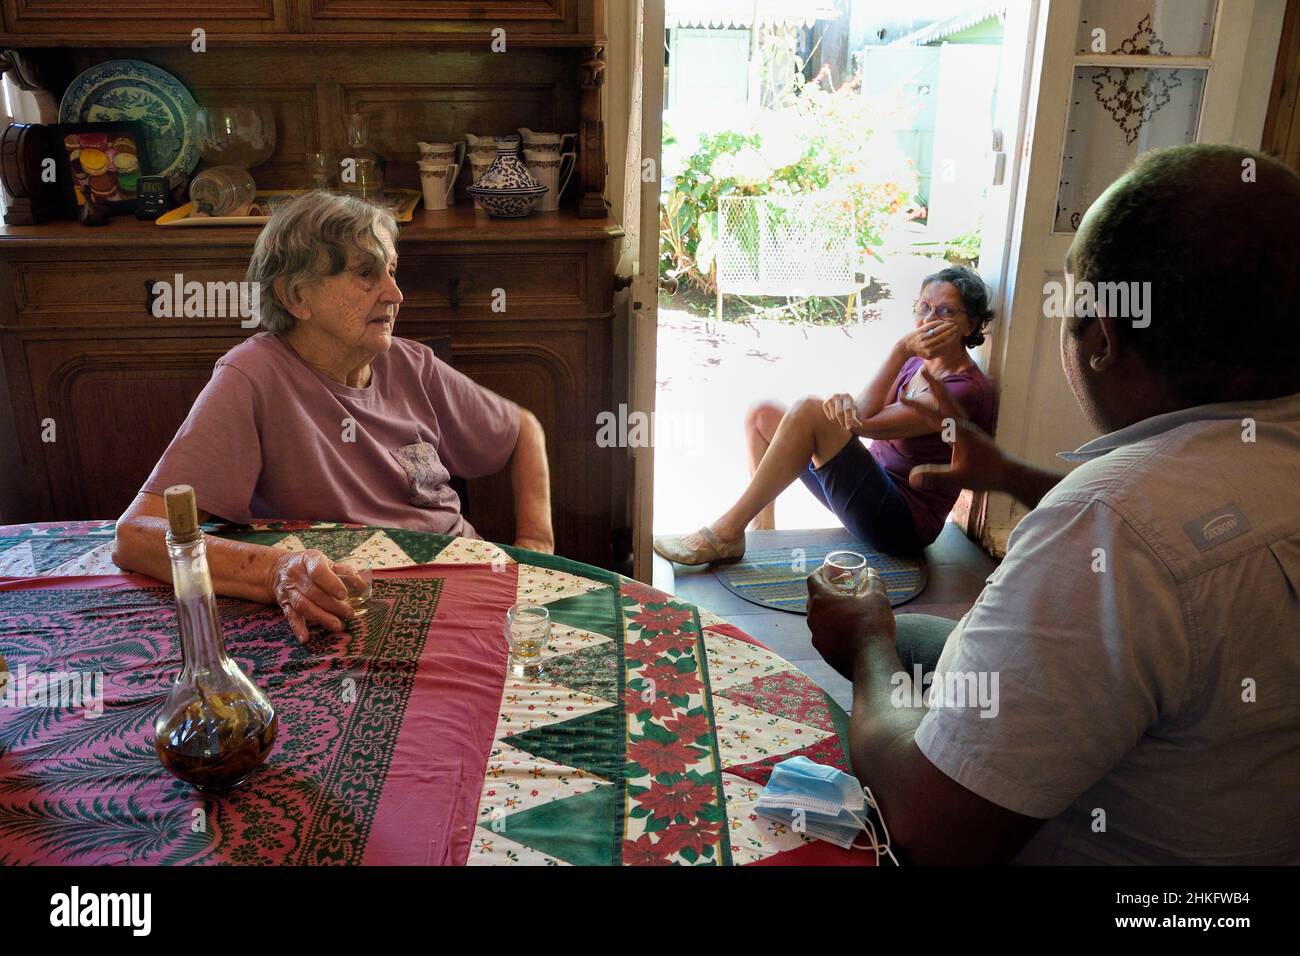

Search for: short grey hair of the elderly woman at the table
xmin=244 ymin=190 xmax=398 ymax=333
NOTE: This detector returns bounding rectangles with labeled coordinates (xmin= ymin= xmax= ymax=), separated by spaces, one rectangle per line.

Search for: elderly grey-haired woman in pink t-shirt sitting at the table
xmin=113 ymin=193 xmax=555 ymax=641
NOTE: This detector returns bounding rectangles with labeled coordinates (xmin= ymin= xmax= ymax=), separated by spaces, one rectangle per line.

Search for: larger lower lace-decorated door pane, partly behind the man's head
xmin=1054 ymin=66 xmax=1205 ymax=233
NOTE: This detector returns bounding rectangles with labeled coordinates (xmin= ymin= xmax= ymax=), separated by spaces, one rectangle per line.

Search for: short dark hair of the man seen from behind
xmin=1067 ymin=144 xmax=1300 ymax=405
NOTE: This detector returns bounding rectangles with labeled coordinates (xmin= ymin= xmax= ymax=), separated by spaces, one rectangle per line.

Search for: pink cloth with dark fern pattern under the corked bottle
xmin=0 ymin=564 xmax=515 ymax=864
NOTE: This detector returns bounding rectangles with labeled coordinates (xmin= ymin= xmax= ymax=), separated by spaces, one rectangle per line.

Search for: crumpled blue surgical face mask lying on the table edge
xmin=754 ymin=757 xmax=898 ymax=864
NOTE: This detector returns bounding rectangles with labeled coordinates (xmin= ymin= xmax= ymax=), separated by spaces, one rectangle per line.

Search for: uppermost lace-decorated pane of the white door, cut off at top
xmin=1078 ymin=0 xmax=1216 ymax=56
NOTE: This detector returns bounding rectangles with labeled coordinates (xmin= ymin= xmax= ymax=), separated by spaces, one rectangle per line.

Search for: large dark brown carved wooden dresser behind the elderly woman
xmin=0 ymin=0 xmax=625 ymax=567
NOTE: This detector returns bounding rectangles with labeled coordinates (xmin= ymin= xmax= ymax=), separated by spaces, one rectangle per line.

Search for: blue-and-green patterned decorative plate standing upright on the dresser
xmin=59 ymin=60 xmax=199 ymax=176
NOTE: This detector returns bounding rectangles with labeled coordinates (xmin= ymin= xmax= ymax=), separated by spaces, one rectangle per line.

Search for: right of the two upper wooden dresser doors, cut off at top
xmin=296 ymin=0 xmax=592 ymax=36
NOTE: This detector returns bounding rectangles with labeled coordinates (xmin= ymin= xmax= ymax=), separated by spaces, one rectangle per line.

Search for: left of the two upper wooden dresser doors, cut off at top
xmin=3 ymin=0 xmax=289 ymax=35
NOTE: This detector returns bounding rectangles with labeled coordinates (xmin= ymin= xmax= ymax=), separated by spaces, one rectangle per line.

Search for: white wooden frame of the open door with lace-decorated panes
xmin=983 ymin=0 xmax=1255 ymax=554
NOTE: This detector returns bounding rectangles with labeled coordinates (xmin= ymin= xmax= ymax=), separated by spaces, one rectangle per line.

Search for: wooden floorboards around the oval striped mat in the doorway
xmin=653 ymin=523 xmax=996 ymax=710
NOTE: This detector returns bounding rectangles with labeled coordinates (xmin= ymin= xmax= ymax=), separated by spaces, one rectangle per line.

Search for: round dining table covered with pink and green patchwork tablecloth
xmin=0 ymin=520 xmax=875 ymax=866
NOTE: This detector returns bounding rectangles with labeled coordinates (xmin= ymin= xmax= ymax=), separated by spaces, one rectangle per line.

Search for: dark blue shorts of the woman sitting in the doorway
xmin=800 ymin=438 xmax=926 ymax=555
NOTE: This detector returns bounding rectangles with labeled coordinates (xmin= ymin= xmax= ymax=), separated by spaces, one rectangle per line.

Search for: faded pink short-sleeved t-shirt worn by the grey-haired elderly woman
xmin=140 ymin=332 xmax=519 ymax=537
